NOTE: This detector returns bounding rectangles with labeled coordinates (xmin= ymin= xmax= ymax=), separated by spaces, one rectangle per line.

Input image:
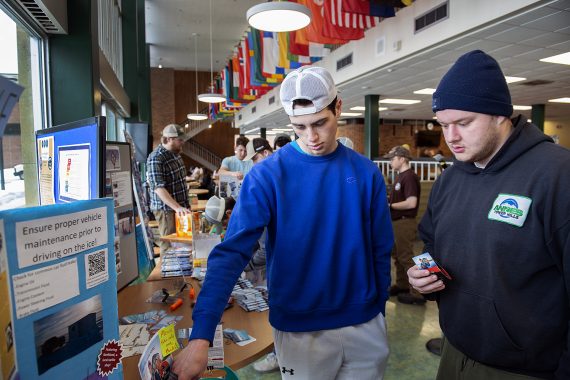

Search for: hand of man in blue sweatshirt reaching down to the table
xmin=172 ymin=339 xmax=210 ymax=380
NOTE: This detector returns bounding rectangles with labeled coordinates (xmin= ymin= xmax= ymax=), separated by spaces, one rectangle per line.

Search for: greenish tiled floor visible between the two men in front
xmin=237 ymin=244 xmax=441 ymax=380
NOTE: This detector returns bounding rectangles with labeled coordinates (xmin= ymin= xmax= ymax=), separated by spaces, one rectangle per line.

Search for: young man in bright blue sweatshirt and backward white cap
xmin=173 ymin=67 xmax=394 ymax=380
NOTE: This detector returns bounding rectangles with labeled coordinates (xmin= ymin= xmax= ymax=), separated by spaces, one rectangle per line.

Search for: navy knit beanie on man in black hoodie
xmin=431 ymin=50 xmax=513 ymax=117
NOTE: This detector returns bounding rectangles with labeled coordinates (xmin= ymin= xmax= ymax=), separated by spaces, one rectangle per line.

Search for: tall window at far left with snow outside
xmin=0 ymin=5 xmax=47 ymax=209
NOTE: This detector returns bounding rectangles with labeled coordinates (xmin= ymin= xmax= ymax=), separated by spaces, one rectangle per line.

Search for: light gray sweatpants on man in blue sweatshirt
xmin=273 ymin=313 xmax=389 ymax=380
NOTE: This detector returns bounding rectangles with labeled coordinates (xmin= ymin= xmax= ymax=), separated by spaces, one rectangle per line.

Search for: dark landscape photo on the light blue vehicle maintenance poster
xmin=34 ymin=295 xmax=103 ymax=375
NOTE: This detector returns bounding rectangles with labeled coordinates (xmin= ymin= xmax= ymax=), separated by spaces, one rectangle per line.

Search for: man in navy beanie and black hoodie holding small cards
xmin=408 ymin=50 xmax=570 ymax=380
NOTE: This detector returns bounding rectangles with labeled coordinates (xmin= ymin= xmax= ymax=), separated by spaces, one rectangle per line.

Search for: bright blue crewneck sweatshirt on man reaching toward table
xmin=191 ymin=144 xmax=394 ymax=341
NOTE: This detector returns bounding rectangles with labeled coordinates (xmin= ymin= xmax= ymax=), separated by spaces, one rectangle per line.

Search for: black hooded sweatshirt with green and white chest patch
xmin=419 ymin=116 xmax=570 ymax=380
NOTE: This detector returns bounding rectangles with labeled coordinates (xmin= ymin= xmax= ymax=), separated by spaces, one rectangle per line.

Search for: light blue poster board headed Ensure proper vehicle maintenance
xmin=0 ymin=199 xmax=123 ymax=380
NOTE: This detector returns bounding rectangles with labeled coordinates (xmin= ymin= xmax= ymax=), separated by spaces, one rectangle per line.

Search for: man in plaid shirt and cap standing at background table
xmin=146 ymin=124 xmax=190 ymax=254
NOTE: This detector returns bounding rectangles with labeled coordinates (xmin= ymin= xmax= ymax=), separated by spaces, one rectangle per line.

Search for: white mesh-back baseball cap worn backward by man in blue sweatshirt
xmin=279 ymin=66 xmax=337 ymax=116
